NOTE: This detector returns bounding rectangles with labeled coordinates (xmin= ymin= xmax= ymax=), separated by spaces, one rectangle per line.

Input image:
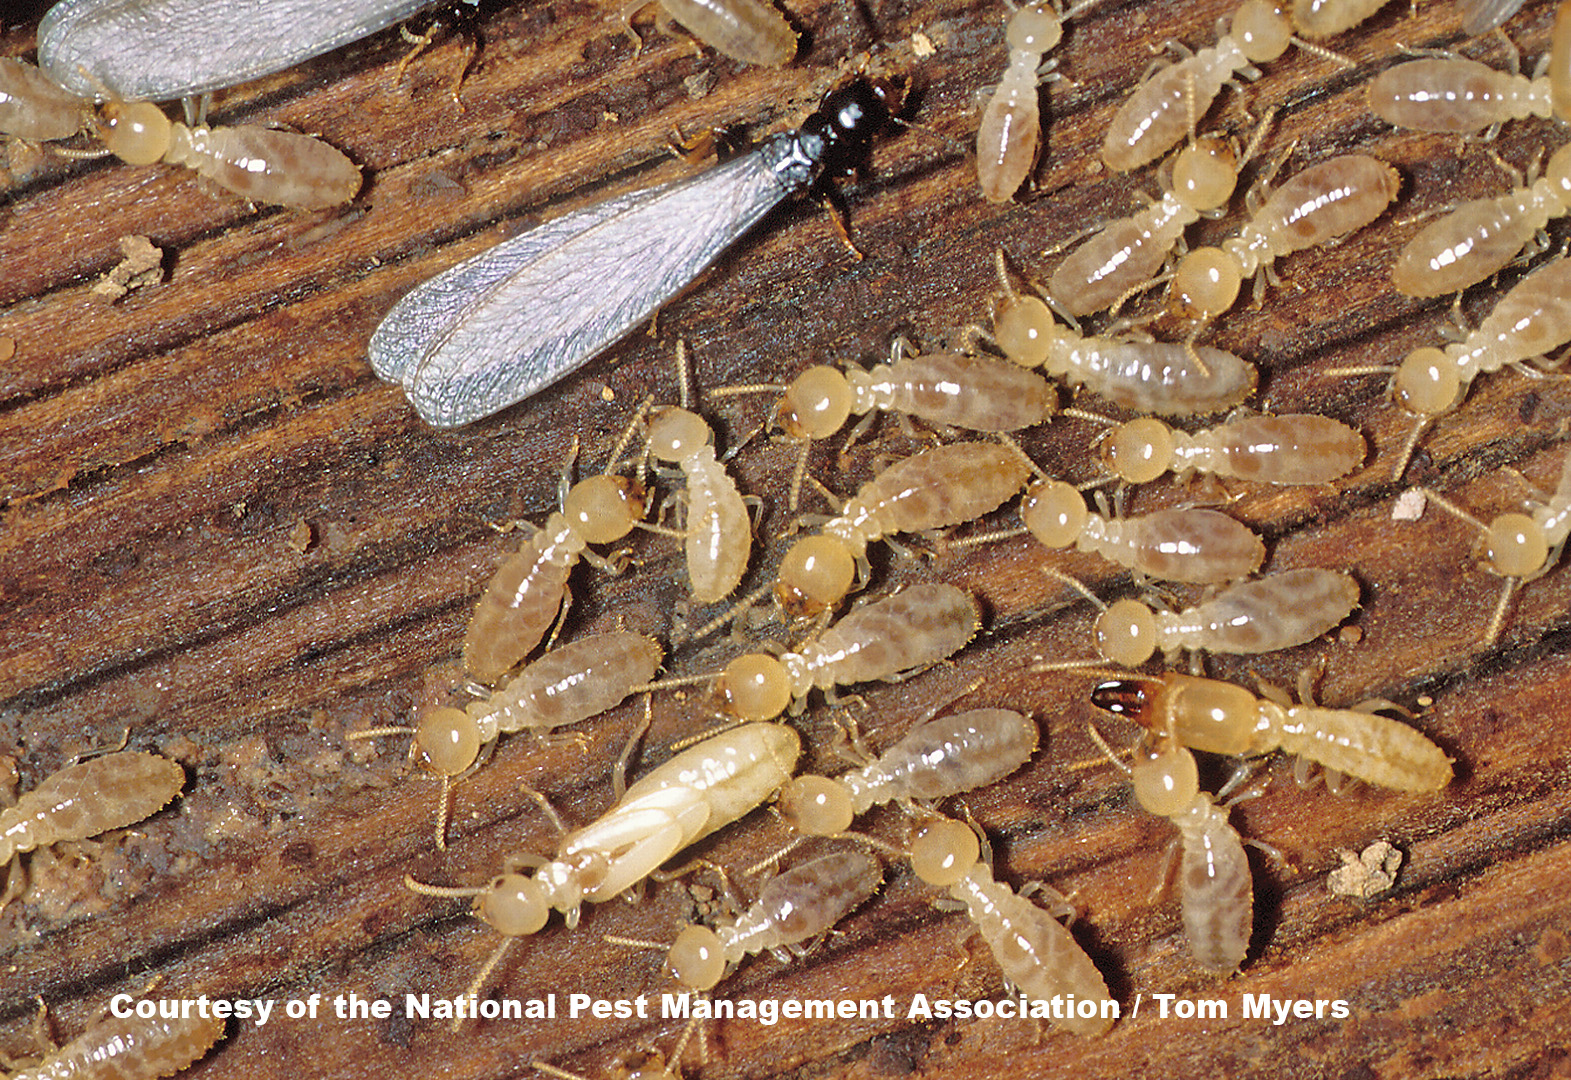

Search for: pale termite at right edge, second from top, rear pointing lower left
xmin=1390 ymin=143 xmax=1571 ymax=296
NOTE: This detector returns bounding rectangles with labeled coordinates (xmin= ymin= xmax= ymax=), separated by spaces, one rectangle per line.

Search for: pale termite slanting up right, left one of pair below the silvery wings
xmin=463 ymin=415 xmax=647 ymax=682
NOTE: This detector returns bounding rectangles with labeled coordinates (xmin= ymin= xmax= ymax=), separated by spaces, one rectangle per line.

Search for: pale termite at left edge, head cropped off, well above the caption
xmin=0 ymin=750 xmax=185 ymax=907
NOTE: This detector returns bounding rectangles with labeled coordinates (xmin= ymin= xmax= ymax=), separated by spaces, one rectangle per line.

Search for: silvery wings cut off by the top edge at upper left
xmin=38 ymin=0 xmax=432 ymax=101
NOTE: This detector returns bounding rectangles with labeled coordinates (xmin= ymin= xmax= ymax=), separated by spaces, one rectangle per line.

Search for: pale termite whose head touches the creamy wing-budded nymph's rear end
xmin=776 ymin=709 xmax=1038 ymax=836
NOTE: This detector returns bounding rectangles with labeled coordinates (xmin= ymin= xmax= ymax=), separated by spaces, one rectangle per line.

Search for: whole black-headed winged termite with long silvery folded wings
xmin=369 ymin=79 xmax=900 ymax=428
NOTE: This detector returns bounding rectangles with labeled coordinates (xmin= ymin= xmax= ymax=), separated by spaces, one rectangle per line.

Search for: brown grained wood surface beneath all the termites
xmin=0 ymin=0 xmax=1571 ymax=1080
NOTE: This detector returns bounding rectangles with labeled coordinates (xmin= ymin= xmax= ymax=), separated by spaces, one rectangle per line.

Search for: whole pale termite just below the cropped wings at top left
xmin=94 ymin=101 xmax=361 ymax=211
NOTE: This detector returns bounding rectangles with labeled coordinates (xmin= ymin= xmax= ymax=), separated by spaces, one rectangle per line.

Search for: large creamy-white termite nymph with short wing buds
xmin=404 ymin=723 xmax=801 ymax=1012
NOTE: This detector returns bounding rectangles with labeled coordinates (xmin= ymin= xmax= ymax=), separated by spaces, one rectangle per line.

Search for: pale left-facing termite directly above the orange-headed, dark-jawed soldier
xmin=1045 ymin=568 xmax=1359 ymax=668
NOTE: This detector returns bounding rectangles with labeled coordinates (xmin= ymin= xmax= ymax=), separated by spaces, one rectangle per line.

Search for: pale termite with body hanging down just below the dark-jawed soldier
xmin=1090 ymin=728 xmax=1255 ymax=975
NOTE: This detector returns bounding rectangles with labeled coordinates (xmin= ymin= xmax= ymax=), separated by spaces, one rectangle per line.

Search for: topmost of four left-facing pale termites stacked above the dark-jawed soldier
xmin=993 ymin=258 xmax=1257 ymax=417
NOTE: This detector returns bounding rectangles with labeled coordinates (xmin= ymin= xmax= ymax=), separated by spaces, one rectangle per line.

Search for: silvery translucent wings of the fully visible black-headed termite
xmin=379 ymin=151 xmax=790 ymax=428
